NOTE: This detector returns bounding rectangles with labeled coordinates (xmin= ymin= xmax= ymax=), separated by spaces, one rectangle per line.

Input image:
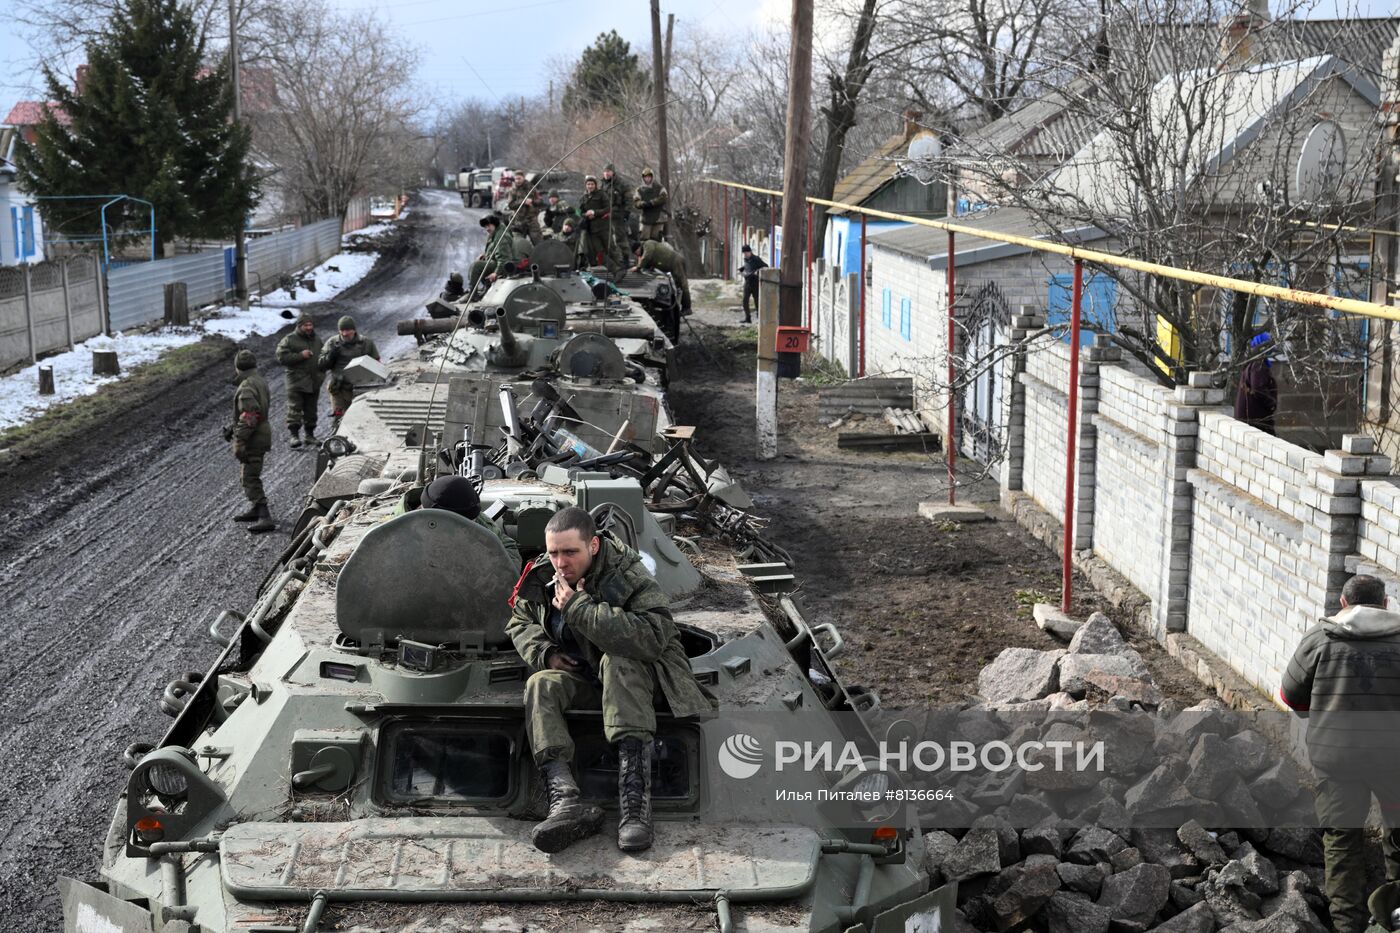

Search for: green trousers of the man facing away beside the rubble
xmin=1317 ymin=769 xmax=1400 ymax=933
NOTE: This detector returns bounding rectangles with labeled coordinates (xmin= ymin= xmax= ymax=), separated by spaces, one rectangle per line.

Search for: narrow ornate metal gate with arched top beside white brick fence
xmin=958 ymin=282 xmax=1011 ymax=464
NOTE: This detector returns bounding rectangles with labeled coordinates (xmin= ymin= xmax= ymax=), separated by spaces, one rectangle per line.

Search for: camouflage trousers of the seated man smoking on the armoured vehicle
xmin=525 ymin=654 xmax=659 ymax=763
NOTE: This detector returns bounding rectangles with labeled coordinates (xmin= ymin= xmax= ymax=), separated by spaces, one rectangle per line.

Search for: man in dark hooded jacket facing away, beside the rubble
xmin=1278 ymin=574 xmax=1400 ymax=933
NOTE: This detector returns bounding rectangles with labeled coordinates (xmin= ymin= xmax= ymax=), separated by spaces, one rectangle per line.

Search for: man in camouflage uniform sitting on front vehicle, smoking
xmin=505 ymin=507 xmax=714 ymax=852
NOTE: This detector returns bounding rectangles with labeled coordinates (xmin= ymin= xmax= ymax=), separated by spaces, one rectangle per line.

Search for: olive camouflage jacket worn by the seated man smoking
xmin=505 ymin=534 xmax=714 ymax=716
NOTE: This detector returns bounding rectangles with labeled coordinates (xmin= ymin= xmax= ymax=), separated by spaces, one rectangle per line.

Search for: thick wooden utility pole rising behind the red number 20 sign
xmin=778 ymin=0 xmax=812 ymax=378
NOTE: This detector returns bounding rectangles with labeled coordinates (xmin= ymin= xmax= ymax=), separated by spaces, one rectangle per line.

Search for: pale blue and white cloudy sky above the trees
xmin=0 ymin=0 xmax=1400 ymax=112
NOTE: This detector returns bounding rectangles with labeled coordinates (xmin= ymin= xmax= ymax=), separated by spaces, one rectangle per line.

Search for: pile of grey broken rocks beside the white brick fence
xmin=927 ymin=614 xmax=1327 ymax=933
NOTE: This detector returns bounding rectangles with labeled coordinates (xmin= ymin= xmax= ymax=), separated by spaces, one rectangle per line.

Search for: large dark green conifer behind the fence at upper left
xmin=18 ymin=0 xmax=258 ymax=247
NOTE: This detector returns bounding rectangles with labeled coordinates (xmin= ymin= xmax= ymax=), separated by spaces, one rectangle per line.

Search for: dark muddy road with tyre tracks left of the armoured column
xmin=0 ymin=191 xmax=482 ymax=933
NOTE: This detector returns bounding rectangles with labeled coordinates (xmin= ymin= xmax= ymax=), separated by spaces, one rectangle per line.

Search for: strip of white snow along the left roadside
xmin=0 ymin=233 xmax=392 ymax=430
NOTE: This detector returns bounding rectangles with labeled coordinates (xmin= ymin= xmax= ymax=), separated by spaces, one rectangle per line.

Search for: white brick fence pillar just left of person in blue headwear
xmin=1152 ymin=373 xmax=1225 ymax=640
